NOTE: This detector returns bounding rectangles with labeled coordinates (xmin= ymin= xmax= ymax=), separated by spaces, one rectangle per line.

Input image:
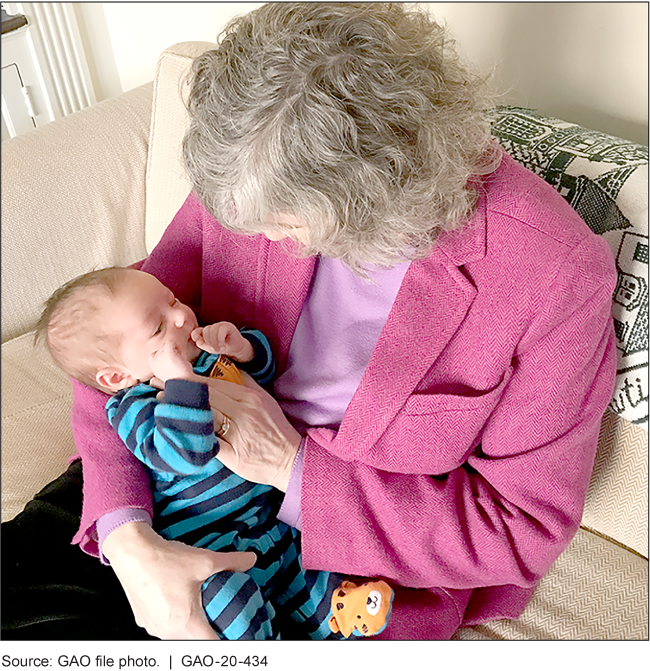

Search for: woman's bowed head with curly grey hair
xmin=183 ymin=3 xmax=500 ymax=269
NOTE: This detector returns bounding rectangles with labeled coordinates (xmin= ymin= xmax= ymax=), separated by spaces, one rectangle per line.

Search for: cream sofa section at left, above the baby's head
xmin=2 ymin=84 xmax=152 ymax=342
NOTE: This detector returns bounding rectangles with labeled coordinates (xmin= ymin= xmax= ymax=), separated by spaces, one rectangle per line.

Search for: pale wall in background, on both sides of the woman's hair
xmin=75 ymin=2 xmax=648 ymax=144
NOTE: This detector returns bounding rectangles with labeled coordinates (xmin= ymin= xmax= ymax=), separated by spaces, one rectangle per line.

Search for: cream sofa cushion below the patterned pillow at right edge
xmin=582 ymin=409 xmax=648 ymax=557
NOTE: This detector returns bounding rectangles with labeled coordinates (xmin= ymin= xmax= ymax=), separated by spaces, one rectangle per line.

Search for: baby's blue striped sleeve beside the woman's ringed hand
xmin=106 ymin=380 xmax=219 ymax=474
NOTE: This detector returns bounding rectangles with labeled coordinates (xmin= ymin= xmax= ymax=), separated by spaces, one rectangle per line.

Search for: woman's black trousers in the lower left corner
xmin=0 ymin=461 xmax=151 ymax=641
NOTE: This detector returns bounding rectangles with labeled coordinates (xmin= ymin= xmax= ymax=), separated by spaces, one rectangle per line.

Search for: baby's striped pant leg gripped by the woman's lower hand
xmin=202 ymin=571 xmax=279 ymax=641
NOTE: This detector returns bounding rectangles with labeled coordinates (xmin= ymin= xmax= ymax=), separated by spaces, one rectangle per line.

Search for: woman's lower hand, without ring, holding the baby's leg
xmin=102 ymin=522 xmax=256 ymax=640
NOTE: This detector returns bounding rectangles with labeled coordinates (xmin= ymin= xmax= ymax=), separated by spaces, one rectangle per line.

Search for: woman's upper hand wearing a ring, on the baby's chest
xmin=207 ymin=374 xmax=302 ymax=492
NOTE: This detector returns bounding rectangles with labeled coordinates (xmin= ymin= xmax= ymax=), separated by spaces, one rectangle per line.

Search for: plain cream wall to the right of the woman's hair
xmin=428 ymin=2 xmax=648 ymax=144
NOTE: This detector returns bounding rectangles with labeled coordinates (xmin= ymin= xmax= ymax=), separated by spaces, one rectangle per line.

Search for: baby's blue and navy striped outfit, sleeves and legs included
xmin=106 ymin=329 xmax=342 ymax=640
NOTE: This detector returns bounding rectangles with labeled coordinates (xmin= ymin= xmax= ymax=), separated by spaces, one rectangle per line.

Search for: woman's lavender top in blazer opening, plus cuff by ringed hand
xmin=275 ymin=258 xmax=410 ymax=529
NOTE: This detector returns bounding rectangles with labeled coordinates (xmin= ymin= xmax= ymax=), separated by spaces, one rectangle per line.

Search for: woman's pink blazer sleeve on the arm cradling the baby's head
xmin=72 ymin=195 xmax=203 ymax=556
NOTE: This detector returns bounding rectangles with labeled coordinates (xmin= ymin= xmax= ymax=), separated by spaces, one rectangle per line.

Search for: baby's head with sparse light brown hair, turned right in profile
xmin=36 ymin=268 xmax=201 ymax=393
